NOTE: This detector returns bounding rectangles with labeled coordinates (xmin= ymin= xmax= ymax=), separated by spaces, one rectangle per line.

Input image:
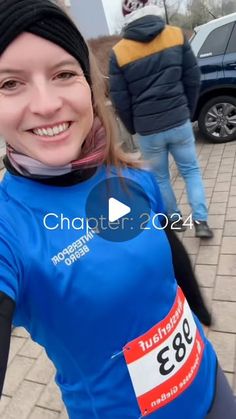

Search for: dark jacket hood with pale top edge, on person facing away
xmin=122 ymin=6 xmax=165 ymax=42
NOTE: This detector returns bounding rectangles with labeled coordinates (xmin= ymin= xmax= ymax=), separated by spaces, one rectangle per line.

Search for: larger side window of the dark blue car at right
xmin=198 ymin=22 xmax=234 ymax=58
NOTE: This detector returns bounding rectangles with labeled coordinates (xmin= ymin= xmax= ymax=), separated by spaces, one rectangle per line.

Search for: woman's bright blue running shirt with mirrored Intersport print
xmin=0 ymin=167 xmax=216 ymax=419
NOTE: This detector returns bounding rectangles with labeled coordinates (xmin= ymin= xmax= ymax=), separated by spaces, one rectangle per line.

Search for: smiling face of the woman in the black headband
xmin=0 ymin=33 xmax=93 ymax=166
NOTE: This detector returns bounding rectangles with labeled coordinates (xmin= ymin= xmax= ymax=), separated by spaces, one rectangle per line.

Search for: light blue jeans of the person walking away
xmin=138 ymin=121 xmax=208 ymax=221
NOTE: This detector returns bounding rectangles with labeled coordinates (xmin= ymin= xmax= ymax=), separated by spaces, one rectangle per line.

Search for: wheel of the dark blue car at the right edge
xmin=198 ymin=96 xmax=236 ymax=143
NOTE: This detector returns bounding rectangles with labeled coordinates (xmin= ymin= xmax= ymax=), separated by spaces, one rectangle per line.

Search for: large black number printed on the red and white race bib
xmin=156 ymin=318 xmax=193 ymax=375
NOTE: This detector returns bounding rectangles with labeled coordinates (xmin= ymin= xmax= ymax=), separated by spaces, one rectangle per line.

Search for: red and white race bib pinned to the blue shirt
xmin=123 ymin=288 xmax=204 ymax=416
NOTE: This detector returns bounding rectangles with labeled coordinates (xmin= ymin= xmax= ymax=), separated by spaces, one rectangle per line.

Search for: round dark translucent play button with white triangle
xmin=85 ymin=176 xmax=151 ymax=243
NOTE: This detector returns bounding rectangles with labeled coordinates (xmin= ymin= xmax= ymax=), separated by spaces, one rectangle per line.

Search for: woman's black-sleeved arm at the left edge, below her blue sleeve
xmin=0 ymin=291 xmax=15 ymax=397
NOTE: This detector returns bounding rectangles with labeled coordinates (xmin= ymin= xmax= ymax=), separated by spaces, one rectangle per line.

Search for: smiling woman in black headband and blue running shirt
xmin=0 ymin=0 xmax=235 ymax=419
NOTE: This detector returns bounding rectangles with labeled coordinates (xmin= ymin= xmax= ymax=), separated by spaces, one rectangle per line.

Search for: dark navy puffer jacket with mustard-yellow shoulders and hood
xmin=110 ymin=15 xmax=200 ymax=135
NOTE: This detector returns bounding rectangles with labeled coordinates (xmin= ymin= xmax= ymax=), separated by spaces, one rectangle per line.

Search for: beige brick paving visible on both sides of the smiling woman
xmin=0 ymin=130 xmax=236 ymax=419
